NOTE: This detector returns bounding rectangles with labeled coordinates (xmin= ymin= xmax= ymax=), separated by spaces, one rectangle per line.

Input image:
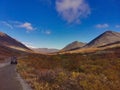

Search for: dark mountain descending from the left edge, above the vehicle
xmin=0 ymin=32 xmax=30 ymax=51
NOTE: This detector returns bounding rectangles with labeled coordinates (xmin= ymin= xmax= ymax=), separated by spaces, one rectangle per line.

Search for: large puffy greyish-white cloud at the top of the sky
xmin=56 ymin=0 xmax=91 ymax=23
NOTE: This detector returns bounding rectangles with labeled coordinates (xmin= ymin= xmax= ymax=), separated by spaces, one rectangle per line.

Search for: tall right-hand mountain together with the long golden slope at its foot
xmin=60 ymin=31 xmax=120 ymax=54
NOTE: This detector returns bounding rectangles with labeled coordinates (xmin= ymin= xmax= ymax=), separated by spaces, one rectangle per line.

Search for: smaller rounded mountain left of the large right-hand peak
xmin=61 ymin=41 xmax=86 ymax=51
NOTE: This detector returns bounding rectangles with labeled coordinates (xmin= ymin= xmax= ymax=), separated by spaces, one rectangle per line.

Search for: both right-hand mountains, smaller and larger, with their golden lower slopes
xmin=61 ymin=31 xmax=120 ymax=52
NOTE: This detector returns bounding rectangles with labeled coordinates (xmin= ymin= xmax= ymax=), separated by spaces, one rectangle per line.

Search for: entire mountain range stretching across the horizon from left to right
xmin=0 ymin=31 xmax=120 ymax=55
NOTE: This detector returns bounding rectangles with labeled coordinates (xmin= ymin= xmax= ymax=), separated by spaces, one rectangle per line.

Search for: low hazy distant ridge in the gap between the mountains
xmin=32 ymin=48 xmax=59 ymax=54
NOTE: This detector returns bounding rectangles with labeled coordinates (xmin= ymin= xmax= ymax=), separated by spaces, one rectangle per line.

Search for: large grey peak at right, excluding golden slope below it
xmin=84 ymin=31 xmax=120 ymax=48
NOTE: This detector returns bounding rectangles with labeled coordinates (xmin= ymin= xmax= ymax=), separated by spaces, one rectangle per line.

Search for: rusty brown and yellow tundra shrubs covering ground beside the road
xmin=17 ymin=47 xmax=120 ymax=90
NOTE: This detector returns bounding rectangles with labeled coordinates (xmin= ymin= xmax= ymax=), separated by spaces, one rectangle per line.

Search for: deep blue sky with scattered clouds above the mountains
xmin=0 ymin=0 xmax=120 ymax=49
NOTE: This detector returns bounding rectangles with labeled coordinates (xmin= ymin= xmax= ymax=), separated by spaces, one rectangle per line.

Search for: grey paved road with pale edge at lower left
xmin=0 ymin=64 xmax=31 ymax=90
